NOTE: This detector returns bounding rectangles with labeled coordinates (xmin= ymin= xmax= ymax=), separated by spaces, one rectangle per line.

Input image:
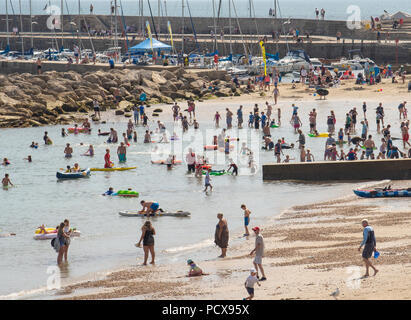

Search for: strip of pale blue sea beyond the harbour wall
xmin=0 ymin=0 xmax=411 ymax=20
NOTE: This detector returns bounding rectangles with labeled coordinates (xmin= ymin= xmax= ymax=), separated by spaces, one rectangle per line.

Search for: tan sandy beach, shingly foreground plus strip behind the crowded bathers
xmin=52 ymin=74 xmax=411 ymax=300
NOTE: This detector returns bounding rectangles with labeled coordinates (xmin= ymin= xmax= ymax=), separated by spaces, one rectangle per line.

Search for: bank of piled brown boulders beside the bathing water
xmin=0 ymin=69 xmax=244 ymax=127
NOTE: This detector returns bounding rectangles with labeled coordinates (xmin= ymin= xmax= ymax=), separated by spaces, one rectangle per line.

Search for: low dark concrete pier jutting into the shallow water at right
xmin=263 ymin=159 xmax=411 ymax=181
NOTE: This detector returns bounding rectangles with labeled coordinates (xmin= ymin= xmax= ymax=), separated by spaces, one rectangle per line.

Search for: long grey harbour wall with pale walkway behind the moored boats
xmin=0 ymin=15 xmax=411 ymax=63
